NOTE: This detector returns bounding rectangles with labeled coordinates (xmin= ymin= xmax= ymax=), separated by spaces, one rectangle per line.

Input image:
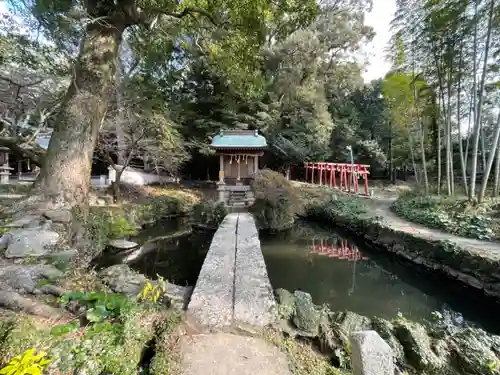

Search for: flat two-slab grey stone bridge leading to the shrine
xmin=187 ymin=213 xmax=276 ymax=329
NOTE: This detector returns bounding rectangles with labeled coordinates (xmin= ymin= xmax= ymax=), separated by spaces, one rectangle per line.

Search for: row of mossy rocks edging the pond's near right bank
xmin=276 ymin=289 xmax=500 ymax=375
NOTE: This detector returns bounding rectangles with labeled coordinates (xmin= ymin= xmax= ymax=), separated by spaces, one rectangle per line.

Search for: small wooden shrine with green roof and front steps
xmin=210 ymin=130 xmax=267 ymax=206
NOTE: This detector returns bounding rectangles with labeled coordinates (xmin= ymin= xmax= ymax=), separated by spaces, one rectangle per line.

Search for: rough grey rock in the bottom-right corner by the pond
xmin=449 ymin=328 xmax=499 ymax=375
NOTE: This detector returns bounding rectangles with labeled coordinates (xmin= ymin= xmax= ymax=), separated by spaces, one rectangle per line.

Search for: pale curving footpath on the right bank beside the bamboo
xmin=370 ymin=197 xmax=500 ymax=260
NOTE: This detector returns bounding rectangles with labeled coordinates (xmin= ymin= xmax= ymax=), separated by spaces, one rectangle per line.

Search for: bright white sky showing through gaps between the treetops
xmin=0 ymin=0 xmax=396 ymax=82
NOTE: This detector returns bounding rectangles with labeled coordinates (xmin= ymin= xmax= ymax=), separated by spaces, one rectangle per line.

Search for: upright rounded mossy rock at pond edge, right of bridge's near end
xmin=292 ymin=290 xmax=321 ymax=337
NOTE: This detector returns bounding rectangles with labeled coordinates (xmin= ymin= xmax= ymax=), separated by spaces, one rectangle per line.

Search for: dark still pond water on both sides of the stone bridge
xmin=97 ymin=220 xmax=500 ymax=333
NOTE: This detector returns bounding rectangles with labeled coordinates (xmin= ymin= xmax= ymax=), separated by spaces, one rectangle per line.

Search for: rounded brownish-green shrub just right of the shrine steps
xmin=250 ymin=169 xmax=299 ymax=230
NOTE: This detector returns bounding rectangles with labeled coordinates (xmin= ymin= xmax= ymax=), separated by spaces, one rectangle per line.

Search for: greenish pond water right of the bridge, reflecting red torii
xmin=260 ymin=222 xmax=500 ymax=332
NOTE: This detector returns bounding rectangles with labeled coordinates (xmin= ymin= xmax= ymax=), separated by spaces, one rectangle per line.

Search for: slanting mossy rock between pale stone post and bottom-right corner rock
xmin=394 ymin=321 xmax=447 ymax=372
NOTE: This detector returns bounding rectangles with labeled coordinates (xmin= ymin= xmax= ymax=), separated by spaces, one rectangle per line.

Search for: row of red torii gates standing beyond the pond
xmin=304 ymin=162 xmax=370 ymax=195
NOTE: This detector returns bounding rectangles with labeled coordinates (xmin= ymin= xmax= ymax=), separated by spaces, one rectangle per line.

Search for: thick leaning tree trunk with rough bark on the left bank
xmin=35 ymin=19 xmax=124 ymax=207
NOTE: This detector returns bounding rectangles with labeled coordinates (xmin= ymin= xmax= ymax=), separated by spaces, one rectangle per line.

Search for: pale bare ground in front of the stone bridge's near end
xmin=181 ymin=333 xmax=291 ymax=375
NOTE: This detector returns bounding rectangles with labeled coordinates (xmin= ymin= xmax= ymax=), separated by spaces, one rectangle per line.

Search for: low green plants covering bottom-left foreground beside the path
xmin=0 ymin=292 xmax=171 ymax=375
